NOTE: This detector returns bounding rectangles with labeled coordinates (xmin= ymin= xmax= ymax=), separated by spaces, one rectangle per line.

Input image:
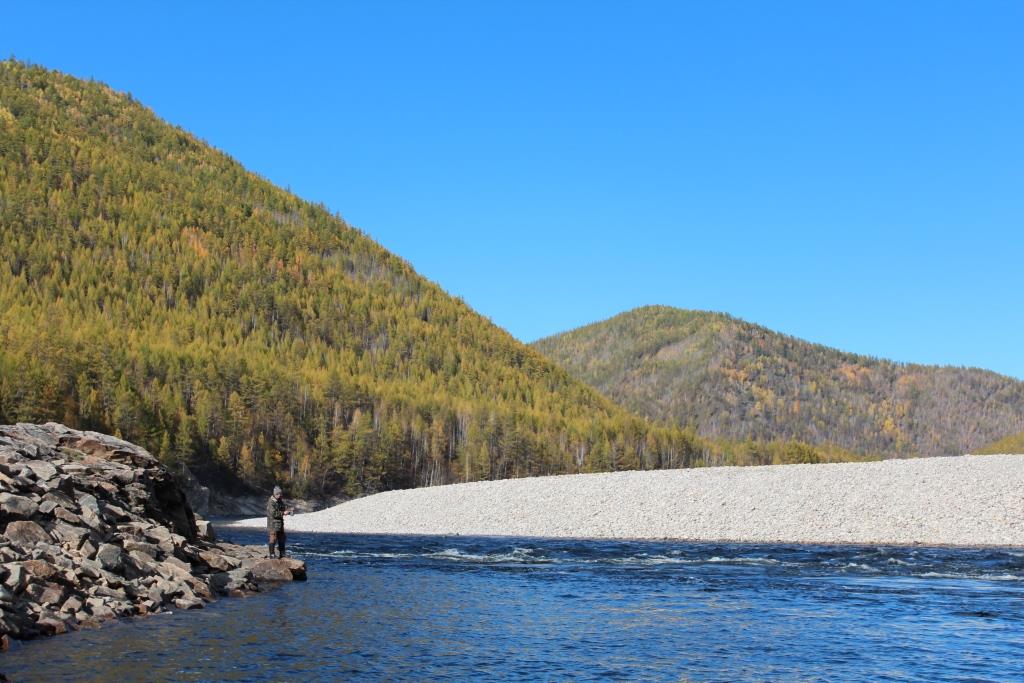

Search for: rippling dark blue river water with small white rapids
xmin=0 ymin=530 xmax=1024 ymax=683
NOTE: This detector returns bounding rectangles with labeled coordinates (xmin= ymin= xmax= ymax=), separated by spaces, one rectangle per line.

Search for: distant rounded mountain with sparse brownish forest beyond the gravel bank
xmin=534 ymin=306 xmax=1024 ymax=457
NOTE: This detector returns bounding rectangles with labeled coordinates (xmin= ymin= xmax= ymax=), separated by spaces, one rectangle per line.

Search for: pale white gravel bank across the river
xmin=234 ymin=455 xmax=1024 ymax=546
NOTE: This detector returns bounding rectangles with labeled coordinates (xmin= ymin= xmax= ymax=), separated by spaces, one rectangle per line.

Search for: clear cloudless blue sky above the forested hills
xmin=6 ymin=0 xmax=1024 ymax=378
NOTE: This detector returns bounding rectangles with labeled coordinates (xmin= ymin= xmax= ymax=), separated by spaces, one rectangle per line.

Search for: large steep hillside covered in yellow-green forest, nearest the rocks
xmin=0 ymin=60 xmax=697 ymax=495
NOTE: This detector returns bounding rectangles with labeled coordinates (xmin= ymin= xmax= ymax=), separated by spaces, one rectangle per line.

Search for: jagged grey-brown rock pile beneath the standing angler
xmin=0 ymin=423 xmax=305 ymax=649
